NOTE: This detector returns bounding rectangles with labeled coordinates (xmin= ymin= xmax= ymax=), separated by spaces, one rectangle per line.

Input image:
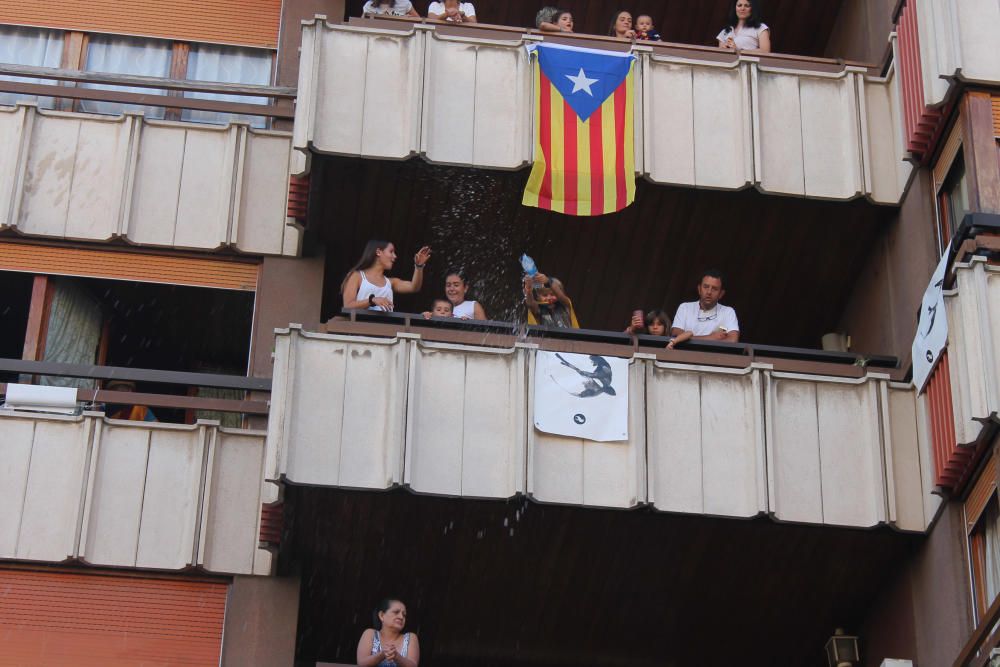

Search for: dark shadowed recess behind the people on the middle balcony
xmin=308 ymin=156 xmax=896 ymax=353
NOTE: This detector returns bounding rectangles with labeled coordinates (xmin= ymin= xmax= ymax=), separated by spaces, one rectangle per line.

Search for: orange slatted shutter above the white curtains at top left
xmin=0 ymin=0 xmax=281 ymax=49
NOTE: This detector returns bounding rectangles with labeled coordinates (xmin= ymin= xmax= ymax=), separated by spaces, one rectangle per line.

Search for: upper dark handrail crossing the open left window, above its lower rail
xmin=0 ymin=359 xmax=271 ymax=392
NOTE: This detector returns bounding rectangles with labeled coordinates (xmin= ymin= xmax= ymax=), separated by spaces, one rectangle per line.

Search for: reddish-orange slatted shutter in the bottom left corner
xmin=0 ymin=569 xmax=229 ymax=667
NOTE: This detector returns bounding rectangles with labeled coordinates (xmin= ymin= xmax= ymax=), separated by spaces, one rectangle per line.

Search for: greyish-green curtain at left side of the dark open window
xmin=39 ymin=279 xmax=104 ymax=389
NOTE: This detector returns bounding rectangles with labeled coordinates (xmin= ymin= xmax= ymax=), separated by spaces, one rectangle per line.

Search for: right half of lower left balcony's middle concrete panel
xmin=136 ymin=425 xmax=205 ymax=570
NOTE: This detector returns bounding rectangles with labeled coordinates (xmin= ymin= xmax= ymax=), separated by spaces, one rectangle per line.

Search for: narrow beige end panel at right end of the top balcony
xmin=862 ymin=73 xmax=913 ymax=204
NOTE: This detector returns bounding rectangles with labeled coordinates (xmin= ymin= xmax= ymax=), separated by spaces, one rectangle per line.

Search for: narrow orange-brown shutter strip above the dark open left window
xmin=0 ymin=243 xmax=259 ymax=292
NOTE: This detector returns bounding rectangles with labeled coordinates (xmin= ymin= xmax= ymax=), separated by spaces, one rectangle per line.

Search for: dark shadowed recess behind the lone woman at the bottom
xmin=279 ymin=485 xmax=921 ymax=667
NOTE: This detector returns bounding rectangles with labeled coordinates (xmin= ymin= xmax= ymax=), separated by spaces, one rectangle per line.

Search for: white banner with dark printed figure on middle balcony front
xmin=535 ymin=352 xmax=629 ymax=442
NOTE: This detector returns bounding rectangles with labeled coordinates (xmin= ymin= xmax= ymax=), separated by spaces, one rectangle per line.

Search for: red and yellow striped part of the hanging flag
xmin=522 ymin=58 xmax=635 ymax=215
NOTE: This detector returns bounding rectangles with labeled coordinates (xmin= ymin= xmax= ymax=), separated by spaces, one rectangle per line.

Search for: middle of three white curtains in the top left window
xmin=80 ymin=35 xmax=172 ymax=118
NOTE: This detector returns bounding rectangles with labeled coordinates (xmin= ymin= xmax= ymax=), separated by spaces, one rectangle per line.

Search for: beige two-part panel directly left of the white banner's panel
xmin=404 ymin=344 xmax=526 ymax=498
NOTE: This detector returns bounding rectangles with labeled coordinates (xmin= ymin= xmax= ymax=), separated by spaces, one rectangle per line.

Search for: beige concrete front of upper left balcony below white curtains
xmin=0 ymin=104 xmax=299 ymax=255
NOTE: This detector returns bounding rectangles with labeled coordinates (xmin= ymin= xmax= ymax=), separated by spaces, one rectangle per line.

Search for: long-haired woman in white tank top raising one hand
xmin=340 ymin=241 xmax=431 ymax=313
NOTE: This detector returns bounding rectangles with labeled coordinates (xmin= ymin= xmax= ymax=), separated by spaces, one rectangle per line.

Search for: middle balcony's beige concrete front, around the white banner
xmin=266 ymin=322 xmax=936 ymax=531
